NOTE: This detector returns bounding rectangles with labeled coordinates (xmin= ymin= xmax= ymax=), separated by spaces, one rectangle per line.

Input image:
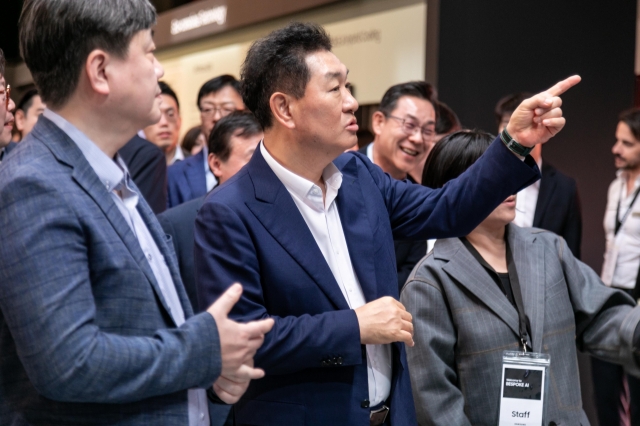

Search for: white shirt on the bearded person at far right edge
xmin=601 ymin=171 xmax=640 ymax=289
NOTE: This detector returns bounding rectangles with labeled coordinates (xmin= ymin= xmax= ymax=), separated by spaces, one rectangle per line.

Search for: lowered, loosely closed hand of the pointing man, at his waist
xmin=356 ymin=296 xmax=414 ymax=346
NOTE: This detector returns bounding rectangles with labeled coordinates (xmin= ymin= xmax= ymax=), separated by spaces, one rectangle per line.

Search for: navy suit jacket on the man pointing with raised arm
xmin=195 ymin=140 xmax=539 ymax=426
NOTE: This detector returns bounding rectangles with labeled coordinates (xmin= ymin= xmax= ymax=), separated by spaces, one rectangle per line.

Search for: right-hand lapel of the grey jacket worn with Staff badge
xmin=508 ymin=225 xmax=545 ymax=352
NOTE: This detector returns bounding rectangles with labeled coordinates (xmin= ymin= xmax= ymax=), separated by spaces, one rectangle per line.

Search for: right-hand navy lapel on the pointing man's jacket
xmin=336 ymin=157 xmax=378 ymax=302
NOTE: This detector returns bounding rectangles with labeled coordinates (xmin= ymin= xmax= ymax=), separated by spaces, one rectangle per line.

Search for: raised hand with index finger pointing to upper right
xmin=507 ymin=75 xmax=581 ymax=146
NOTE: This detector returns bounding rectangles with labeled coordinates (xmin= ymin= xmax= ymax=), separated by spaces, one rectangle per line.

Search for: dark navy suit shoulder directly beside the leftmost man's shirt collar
xmin=118 ymin=135 xmax=167 ymax=214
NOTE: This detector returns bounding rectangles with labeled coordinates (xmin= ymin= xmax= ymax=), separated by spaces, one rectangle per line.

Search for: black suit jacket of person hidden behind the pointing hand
xmin=533 ymin=162 xmax=582 ymax=259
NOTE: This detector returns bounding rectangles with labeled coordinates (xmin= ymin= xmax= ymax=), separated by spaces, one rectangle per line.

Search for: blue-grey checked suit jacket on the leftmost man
xmin=0 ymin=117 xmax=220 ymax=426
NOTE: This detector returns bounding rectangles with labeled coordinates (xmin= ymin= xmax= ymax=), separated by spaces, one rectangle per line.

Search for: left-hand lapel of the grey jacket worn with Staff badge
xmin=434 ymin=238 xmax=519 ymax=336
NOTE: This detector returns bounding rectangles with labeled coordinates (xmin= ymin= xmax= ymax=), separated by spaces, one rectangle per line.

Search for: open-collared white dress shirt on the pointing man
xmin=260 ymin=142 xmax=391 ymax=407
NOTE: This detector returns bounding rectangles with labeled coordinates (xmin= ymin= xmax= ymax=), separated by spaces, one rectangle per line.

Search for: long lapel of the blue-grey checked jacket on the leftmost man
xmin=34 ymin=117 xmax=176 ymax=322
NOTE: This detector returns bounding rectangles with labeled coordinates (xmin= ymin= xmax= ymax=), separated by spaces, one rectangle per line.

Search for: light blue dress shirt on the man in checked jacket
xmin=43 ymin=109 xmax=210 ymax=426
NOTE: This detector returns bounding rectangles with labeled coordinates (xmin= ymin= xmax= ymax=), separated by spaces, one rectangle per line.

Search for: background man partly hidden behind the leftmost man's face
xmin=143 ymin=81 xmax=184 ymax=166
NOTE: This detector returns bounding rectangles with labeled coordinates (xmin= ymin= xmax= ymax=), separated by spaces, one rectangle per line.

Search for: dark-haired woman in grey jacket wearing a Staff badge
xmin=400 ymin=131 xmax=640 ymax=426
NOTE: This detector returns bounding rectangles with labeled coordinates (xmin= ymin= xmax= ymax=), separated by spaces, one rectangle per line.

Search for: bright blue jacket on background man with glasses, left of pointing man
xmin=167 ymin=150 xmax=207 ymax=208
